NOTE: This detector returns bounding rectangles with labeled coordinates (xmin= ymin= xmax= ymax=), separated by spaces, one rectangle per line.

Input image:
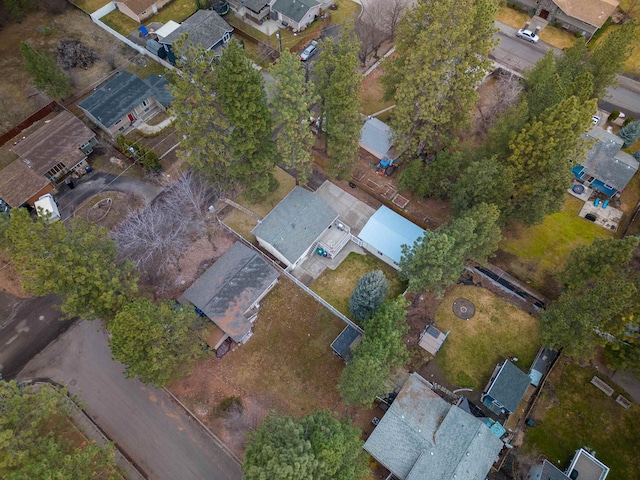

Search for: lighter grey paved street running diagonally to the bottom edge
xmin=18 ymin=321 xmax=242 ymax=480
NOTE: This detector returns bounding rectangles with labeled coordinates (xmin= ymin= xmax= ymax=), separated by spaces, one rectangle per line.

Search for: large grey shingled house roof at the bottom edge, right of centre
xmin=364 ymin=373 xmax=504 ymax=480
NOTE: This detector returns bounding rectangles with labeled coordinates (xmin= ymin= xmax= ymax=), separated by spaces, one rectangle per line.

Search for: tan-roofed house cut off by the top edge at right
xmin=515 ymin=0 xmax=620 ymax=38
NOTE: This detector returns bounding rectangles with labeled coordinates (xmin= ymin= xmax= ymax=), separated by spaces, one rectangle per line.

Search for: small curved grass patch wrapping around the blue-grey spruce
xmin=311 ymin=253 xmax=406 ymax=317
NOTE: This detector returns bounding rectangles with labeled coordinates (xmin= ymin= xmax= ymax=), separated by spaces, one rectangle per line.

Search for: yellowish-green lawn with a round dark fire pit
xmin=435 ymin=286 xmax=539 ymax=389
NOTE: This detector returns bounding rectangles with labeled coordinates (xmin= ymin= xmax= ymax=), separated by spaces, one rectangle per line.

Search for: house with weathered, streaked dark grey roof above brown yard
xmin=179 ymin=242 xmax=280 ymax=349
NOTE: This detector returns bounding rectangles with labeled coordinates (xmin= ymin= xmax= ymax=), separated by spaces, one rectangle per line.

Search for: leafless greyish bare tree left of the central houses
xmin=113 ymin=172 xmax=217 ymax=276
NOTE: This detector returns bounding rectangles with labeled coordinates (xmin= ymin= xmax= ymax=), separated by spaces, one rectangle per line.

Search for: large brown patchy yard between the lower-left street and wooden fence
xmin=171 ymin=277 xmax=370 ymax=454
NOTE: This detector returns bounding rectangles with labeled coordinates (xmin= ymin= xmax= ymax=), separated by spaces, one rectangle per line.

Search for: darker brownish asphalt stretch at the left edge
xmin=0 ymin=292 xmax=73 ymax=379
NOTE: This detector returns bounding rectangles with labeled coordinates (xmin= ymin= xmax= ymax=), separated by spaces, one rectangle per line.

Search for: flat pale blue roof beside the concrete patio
xmin=358 ymin=206 xmax=424 ymax=263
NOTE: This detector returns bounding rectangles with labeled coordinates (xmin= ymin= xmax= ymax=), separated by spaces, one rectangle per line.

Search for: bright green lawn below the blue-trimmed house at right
xmin=497 ymin=194 xmax=613 ymax=296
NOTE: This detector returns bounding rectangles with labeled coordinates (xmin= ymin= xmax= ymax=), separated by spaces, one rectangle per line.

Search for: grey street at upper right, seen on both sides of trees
xmin=491 ymin=22 xmax=640 ymax=119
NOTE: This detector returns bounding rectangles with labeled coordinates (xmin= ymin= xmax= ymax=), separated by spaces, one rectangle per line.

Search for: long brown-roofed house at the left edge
xmin=0 ymin=110 xmax=97 ymax=208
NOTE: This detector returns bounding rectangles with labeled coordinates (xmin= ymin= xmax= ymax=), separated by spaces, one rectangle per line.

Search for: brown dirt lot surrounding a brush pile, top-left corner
xmin=0 ymin=7 xmax=132 ymax=132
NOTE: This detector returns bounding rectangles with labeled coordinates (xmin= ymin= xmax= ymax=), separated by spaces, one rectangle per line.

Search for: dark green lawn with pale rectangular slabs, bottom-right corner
xmin=521 ymin=358 xmax=640 ymax=479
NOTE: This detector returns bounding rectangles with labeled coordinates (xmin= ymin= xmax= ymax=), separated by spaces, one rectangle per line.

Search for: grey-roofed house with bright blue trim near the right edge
xmin=572 ymin=127 xmax=640 ymax=197
